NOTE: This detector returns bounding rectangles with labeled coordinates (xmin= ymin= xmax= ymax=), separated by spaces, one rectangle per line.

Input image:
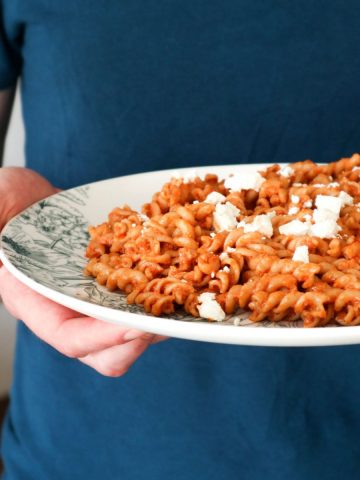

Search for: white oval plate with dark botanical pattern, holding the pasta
xmin=0 ymin=164 xmax=360 ymax=347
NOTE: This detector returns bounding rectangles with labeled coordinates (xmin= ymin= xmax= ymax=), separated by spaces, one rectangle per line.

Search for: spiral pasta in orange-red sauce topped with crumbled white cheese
xmin=85 ymin=154 xmax=360 ymax=327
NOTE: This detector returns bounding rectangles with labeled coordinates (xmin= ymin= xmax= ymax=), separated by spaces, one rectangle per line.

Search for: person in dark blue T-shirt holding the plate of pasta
xmin=0 ymin=0 xmax=360 ymax=480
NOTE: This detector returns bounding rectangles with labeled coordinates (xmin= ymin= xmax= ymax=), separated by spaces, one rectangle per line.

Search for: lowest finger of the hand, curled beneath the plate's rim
xmin=80 ymin=335 xmax=153 ymax=377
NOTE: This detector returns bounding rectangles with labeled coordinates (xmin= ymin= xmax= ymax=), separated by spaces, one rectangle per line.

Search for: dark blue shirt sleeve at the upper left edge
xmin=0 ymin=0 xmax=22 ymax=90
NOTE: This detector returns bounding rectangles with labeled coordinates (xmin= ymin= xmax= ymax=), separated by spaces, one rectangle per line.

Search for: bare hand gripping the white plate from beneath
xmin=0 ymin=168 xmax=165 ymax=377
